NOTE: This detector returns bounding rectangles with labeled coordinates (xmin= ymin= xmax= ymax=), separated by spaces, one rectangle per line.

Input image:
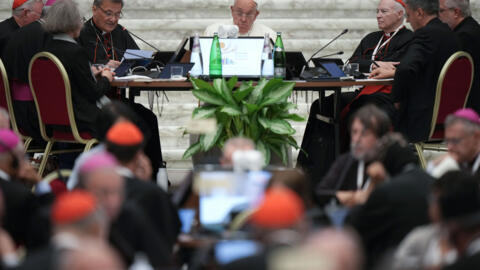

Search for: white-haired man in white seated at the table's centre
xmin=203 ymin=0 xmax=276 ymax=38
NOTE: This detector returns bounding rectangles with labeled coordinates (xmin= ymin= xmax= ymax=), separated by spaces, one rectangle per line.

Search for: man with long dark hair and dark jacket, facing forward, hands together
xmin=314 ymin=105 xmax=391 ymax=206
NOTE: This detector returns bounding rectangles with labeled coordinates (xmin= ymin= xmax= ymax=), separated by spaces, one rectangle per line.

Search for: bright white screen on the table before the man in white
xmin=200 ymin=37 xmax=263 ymax=78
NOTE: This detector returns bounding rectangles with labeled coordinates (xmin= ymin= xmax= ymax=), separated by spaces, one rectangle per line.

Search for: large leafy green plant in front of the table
xmin=183 ymin=77 xmax=304 ymax=165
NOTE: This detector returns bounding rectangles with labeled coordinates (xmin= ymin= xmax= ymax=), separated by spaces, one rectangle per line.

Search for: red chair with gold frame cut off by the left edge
xmin=0 ymin=59 xmax=38 ymax=152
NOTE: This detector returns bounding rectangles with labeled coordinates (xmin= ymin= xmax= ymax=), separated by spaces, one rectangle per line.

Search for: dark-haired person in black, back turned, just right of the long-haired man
xmin=346 ymin=138 xmax=433 ymax=269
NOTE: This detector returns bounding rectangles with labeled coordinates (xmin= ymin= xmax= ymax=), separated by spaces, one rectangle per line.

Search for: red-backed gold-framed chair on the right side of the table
xmin=415 ymin=51 xmax=474 ymax=168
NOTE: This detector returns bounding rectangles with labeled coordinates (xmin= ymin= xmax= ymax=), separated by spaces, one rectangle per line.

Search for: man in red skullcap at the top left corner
xmin=0 ymin=0 xmax=43 ymax=57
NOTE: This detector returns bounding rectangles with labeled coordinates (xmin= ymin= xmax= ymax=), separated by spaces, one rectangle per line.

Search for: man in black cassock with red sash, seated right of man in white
xmin=298 ymin=0 xmax=413 ymax=184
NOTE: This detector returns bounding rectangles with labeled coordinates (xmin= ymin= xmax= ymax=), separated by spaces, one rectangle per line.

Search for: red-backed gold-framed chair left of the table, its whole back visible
xmin=28 ymin=52 xmax=97 ymax=175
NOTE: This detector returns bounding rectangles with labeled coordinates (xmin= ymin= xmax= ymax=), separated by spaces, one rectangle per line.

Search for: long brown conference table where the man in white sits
xmin=111 ymin=79 xmax=393 ymax=156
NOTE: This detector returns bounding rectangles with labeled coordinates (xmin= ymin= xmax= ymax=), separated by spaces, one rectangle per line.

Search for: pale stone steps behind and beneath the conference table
xmin=0 ymin=0 xmax=480 ymax=184
